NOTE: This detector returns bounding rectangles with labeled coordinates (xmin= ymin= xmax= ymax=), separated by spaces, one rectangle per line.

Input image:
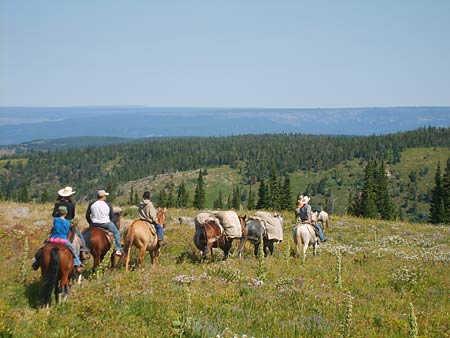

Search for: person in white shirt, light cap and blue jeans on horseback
xmin=86 ymin=190 xmax=123 ymax=256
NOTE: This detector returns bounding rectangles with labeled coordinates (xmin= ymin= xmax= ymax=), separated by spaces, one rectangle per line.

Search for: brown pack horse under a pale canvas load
xmin=194 ymin=214 xmax=246 ymax=261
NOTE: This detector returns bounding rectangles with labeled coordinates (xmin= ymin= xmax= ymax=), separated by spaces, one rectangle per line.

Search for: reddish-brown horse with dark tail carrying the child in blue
xmin=39 ymin=243 xmax=74 ymax=308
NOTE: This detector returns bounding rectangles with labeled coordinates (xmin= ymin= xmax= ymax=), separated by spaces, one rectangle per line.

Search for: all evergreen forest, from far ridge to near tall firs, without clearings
xmin=0 ymin=127 xmax=450 ymax=221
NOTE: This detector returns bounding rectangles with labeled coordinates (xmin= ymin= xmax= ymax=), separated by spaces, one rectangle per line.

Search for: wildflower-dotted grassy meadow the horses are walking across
xmin=0 ymin=202 xmax=450 ymax=337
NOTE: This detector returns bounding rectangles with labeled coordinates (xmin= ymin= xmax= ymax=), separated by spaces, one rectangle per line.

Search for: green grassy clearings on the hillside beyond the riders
xmin=116 ymin=148 xmax=450 ymax=222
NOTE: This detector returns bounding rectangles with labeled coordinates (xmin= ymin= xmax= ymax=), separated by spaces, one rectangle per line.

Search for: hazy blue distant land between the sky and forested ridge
xmin=0 ymin=106 xmax=450 ymax=145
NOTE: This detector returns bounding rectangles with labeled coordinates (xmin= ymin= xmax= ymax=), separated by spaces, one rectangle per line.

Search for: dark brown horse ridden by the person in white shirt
xmin=82 ymin=209 xmax=121 ymax=272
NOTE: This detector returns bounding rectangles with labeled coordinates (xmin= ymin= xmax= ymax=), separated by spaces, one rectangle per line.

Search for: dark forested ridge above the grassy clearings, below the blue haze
xmin=0 ymin=127 xmax=450 ymax=200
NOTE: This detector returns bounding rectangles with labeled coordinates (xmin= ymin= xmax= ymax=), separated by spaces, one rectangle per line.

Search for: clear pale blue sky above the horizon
xmin=0 ymin=0 xmax=450 ymax=108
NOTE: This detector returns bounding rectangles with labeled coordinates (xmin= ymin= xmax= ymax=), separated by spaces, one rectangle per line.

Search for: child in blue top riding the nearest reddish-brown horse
xmin=33 ymin=205 xmax=84 ymax=273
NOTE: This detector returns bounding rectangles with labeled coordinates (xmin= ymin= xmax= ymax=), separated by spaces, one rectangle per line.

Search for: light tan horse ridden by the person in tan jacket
xmin=121 ymin=208 xmax=167 ymax=271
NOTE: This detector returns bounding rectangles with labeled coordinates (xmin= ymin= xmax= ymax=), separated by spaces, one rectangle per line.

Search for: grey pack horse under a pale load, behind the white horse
xmin=238 ymin=212 xmax=283 ymax=258
